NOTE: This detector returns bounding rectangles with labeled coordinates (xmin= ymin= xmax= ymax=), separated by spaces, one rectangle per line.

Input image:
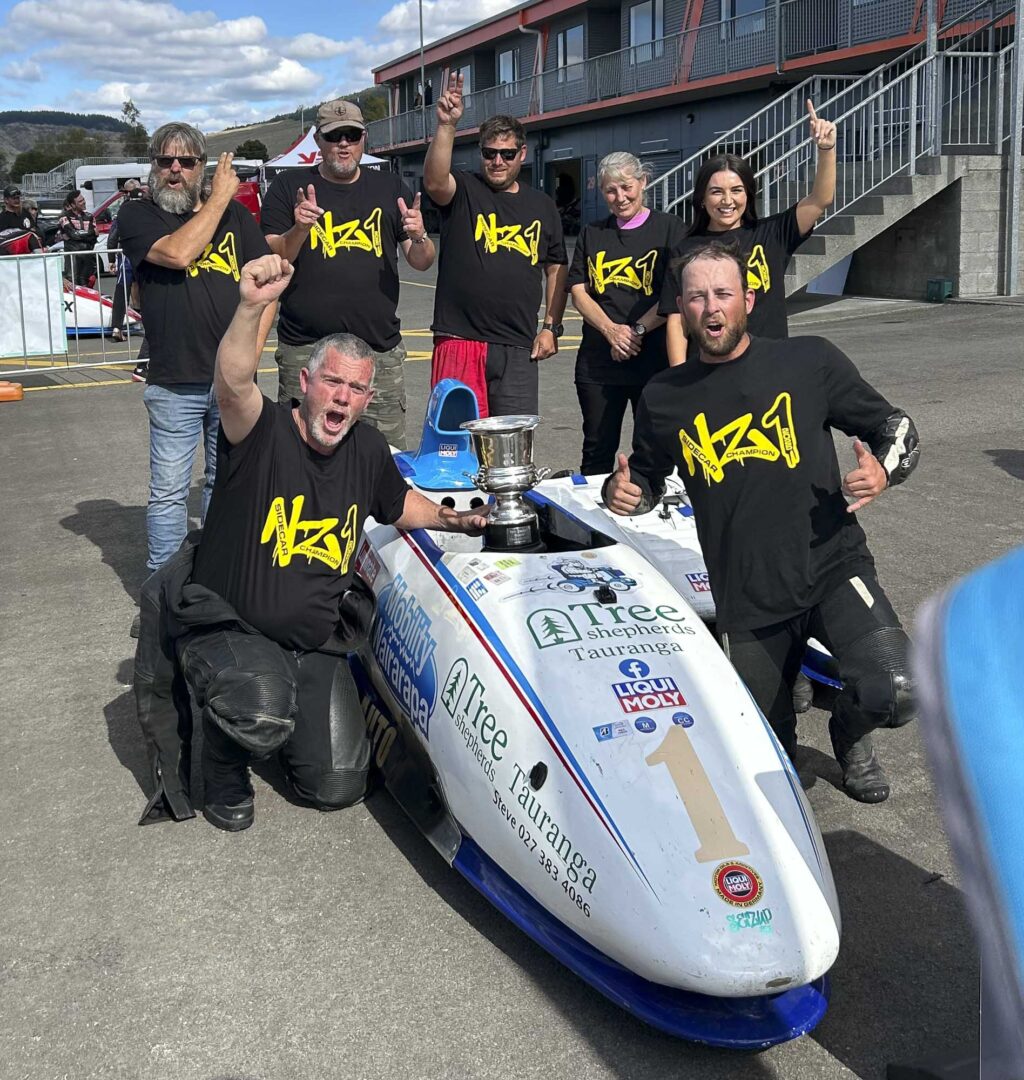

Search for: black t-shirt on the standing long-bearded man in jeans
xmin=118 ymin=199 xmax=270 ymax=387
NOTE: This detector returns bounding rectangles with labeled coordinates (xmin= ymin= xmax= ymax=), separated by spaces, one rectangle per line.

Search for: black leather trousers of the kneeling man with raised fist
xmin=178 ymin=630 xmax=369 ymax=809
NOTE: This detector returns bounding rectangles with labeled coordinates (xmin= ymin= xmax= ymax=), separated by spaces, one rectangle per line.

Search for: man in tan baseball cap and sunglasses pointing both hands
xmin=261 ymin=97 xmax=434 ymax=449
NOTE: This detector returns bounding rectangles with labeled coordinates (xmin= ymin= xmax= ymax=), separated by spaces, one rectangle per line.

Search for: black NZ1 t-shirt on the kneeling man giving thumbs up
xmin=630 ymin=337 xmax=894 ymax=631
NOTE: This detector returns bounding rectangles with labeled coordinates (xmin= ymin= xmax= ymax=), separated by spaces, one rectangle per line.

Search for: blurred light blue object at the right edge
xmin=913 ymin=549 xmax=1024 ymax=1067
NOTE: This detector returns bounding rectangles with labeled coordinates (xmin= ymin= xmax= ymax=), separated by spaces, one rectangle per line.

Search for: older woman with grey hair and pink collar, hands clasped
xmin=568 ymin=151 xmax=686 ymax=473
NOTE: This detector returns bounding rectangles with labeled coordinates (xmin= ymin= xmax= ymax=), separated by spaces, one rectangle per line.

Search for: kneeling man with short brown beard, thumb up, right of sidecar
xmin=604 ymin=243 xmax=918 ymax=802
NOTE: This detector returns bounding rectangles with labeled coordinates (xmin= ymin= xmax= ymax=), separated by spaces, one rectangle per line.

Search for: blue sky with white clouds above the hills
xmin=0 ymin=0 xmax=514 ymax=132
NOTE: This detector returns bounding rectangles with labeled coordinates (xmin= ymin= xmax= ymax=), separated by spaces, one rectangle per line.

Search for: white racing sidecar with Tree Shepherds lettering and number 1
xmin=353 ymin=380 xmax=840 ymax=1049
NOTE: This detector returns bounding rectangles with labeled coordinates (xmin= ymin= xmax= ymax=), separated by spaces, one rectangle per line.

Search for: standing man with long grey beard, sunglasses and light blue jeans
xmin=118 ymin=122 xmax=273 ymax=583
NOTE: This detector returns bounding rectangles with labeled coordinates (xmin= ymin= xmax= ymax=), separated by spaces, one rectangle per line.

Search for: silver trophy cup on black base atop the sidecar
xmin=461 ymin=416 xmax=551 ymax=551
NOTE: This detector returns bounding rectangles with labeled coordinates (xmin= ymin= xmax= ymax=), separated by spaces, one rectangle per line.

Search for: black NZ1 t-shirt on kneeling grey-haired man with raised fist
xmin=192 ymin=397 xmax=408 ymax=649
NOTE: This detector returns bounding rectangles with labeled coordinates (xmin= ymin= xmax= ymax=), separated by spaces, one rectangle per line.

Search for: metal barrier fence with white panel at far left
xmin=0 ymin=249 xmax=143 ymax=377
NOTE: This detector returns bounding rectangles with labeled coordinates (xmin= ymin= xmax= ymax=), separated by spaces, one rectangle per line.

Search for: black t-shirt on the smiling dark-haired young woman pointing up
xmin=658 ymin=206 xmax=813 ymax=338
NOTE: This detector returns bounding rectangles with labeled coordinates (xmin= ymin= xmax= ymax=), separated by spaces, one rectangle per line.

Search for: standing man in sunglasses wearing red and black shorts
xmin=423 ymin=75 xmax=568 ymax=417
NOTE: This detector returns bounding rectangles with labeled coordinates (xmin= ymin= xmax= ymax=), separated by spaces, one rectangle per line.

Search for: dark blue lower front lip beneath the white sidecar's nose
xmin=452 ymin=837 xmax=828 ymax=1050
